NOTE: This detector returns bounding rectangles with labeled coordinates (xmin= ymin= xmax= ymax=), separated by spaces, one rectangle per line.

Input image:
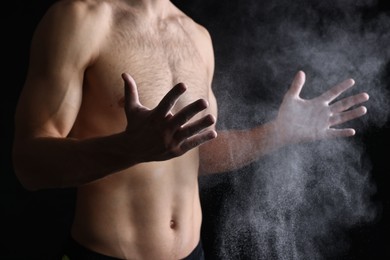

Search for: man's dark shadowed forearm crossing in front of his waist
xmin=14 ymin=133 xmax=137 ymax=190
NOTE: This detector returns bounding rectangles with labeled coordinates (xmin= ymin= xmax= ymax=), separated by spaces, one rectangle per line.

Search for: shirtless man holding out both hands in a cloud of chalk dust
xmin=14 ymin=0 xmax=368 ymax=260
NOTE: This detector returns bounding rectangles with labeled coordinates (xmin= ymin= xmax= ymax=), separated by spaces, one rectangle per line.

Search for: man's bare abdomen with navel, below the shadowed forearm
xmin=72 ymin=149 xmax=202 ymax=260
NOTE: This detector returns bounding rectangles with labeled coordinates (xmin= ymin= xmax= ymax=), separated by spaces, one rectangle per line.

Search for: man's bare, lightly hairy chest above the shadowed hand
xmin=87 ymin=23 xmax=209 ymax=113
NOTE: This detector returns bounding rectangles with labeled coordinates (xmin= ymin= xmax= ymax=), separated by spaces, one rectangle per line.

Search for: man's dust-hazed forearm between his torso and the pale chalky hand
xmin=200 ymin=121 xmax=288 ymax=174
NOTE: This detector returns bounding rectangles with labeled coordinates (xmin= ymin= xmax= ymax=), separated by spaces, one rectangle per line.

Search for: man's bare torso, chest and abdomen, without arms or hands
xmin=66 ymin=1 xmax=210 ymax=259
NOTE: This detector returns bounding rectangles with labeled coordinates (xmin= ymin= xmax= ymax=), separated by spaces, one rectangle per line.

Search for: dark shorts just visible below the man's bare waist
xmin=62 ymin=238 xmax=204 ymax=260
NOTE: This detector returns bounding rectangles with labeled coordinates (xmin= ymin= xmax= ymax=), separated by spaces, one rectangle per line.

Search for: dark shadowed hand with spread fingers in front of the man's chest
xmin=122 ymin=73 xmax=217 ymax=161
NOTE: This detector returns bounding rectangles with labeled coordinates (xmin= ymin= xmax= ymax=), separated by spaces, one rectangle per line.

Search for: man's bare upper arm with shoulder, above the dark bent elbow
xmin=15 ymin=1 xmax=110 ymax=139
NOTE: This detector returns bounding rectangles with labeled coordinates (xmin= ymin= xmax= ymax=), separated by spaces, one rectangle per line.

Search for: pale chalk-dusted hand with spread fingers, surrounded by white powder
xmin=276 ymin=71 xmax=369 ymax=142
